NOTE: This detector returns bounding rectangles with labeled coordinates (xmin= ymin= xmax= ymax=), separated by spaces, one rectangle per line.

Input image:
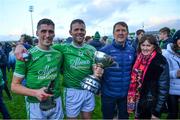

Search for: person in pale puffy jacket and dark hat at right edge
xmin=163 ymin=30 xmax=180 ymax=119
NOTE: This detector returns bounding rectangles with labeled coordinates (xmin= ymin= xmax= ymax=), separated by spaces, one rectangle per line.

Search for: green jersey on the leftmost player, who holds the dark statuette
xmin=14 ymin=46 xmax=62 ymax=103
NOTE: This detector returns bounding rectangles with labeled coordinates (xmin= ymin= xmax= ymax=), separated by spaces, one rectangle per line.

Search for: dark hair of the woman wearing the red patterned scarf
xmin=137 ymin=34 xmax=162 ymax=53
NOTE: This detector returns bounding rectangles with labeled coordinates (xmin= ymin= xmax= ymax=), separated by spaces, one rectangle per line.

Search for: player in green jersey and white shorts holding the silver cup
xmin=53 ymin=19 xmax=103 ymax=119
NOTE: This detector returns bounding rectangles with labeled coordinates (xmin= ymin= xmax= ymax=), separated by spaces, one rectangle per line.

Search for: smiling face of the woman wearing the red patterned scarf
xmin=140 ymin=40 xmax=155 ymax=55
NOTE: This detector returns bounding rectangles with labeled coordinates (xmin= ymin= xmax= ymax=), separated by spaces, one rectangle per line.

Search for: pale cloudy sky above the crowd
xmin=0 ymin=0 xmax=180 ymax=40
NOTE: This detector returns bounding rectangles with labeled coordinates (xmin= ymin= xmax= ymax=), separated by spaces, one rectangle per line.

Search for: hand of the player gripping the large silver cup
xmin=93 ymin=64 xmax=104 ymax=78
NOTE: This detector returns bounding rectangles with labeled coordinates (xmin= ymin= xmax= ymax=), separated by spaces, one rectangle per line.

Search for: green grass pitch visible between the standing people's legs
xmin=0 ymin=72 xmax=167 ymax=119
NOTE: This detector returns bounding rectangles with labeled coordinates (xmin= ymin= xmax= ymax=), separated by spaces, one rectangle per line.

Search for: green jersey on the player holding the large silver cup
xmin=53 ymin=42 xmax=96 ymax=89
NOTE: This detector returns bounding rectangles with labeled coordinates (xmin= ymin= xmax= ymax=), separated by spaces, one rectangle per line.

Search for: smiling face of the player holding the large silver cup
xmin=69 ymin=22 xmax=86 ymax=46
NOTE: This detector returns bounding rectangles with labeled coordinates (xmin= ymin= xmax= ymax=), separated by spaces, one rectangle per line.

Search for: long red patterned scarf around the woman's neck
xmin=127 ymin=51 xmax=156 ymax=113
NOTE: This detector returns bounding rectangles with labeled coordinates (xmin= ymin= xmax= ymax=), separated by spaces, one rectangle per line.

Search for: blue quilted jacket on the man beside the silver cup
xmin=100 ymin=41 xmax=135 ymax=97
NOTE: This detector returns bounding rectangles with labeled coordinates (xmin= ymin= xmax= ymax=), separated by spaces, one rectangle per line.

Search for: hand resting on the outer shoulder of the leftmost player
xmin=14 ymin=45 xmax=28 ymax=61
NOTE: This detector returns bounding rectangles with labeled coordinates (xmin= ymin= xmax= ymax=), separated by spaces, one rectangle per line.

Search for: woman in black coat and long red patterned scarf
xmin=127 ymin=35 xmax=170 ymax=119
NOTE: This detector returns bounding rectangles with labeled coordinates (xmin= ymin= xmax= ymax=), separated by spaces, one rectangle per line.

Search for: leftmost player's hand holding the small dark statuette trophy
xmin=35 ymin=87 xmax=53 ymax=101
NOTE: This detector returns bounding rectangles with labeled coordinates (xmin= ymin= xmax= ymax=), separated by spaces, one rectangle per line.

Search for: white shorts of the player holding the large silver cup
xmin=64 ymin=88 xmax=95 ymax=117
